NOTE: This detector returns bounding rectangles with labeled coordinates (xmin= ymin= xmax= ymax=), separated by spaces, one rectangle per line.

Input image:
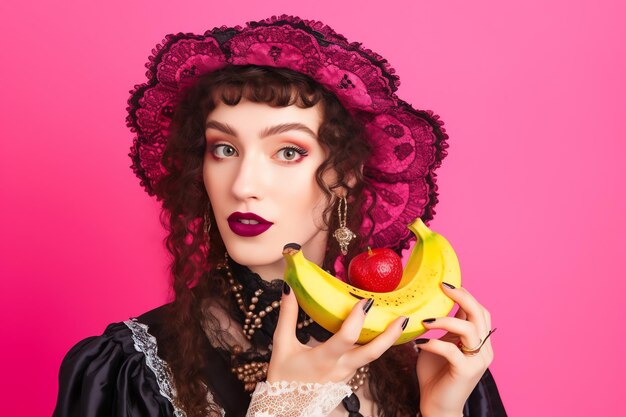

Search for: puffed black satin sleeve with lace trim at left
xmin=53 ymin=321 xmax=178 ymax=417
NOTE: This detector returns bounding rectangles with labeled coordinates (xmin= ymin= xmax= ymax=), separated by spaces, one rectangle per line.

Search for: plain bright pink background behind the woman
xmin=0 ymin=0 xmax=626 ymax=416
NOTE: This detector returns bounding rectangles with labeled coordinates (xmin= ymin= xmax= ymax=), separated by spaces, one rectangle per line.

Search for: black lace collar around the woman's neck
xmin=224 ymin=259 xmax=332 ymax=350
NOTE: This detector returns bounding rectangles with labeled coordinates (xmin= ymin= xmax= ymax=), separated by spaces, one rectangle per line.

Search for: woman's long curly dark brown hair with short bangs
xmin=155 ymin=66 xmax=419 ymax=417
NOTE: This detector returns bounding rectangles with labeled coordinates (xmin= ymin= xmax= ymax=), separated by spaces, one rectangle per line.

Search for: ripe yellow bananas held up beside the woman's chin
xmin=283 ymin=218 xmax=461 ymax=344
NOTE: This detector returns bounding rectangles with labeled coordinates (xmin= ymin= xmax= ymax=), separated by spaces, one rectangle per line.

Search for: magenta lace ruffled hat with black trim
xmin=126 ymin=16 xmax=448 ymax=251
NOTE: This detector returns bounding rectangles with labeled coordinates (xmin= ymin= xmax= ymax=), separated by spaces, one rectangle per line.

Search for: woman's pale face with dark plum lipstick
xmin=203 ymin=100 xmax=328 ymax=280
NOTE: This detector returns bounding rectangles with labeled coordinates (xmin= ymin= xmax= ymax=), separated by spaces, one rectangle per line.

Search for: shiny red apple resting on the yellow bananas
xmin=348 ymin=248 xmax=402 ymax=292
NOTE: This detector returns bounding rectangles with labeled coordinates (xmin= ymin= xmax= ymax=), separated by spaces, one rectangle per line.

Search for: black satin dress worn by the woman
xmin=53 ymin=266 xmax=506 ymax=417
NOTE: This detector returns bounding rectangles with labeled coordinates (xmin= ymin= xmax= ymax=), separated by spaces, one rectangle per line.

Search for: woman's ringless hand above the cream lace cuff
xmin=267 ymin=283 xmax=405 ymax=384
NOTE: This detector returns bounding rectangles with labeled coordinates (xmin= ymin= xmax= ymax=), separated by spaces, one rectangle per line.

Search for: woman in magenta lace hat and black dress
xmin=54 ymin=16 xmax=505 ymax=417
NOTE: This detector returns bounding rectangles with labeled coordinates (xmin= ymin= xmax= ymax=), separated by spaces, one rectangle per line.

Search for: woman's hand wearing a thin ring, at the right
xmin=416 ymin=285 xmax=493 ymax=417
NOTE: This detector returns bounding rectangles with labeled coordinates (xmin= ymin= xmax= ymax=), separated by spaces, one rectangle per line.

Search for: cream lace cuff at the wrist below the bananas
xmin=246 ymin=381 xmax=352 ymax=417
